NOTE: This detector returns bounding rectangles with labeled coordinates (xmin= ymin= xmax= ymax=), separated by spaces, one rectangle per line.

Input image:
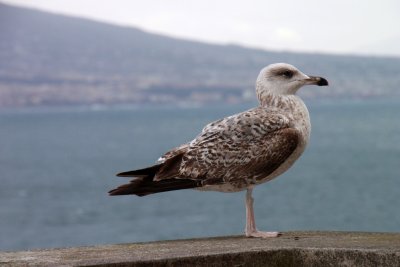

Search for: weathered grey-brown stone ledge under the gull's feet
xmin=0 ymin=232 xmax=400 ymax=266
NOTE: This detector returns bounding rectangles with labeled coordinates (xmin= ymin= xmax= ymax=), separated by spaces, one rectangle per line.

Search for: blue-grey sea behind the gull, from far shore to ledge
xmin=0 ymin=99 xmax=400 ymax=251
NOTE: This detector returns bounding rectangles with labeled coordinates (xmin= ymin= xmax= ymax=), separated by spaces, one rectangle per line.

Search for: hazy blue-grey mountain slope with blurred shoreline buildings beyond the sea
xmin=0 ymin=3 xmax=400 ymax=107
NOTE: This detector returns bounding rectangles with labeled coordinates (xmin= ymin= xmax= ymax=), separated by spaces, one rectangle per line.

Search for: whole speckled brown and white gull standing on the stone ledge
xmin=109 ymin=63 xmax=328 ymax=238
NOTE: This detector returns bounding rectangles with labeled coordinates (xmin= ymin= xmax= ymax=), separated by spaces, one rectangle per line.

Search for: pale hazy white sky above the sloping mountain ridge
xmin=0 ymin=0 xmax=400 ymax=56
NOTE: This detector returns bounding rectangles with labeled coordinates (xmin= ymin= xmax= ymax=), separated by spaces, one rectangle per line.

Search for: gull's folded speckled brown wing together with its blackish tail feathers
xmin=110 ymin=107 xmax=299 ymax=196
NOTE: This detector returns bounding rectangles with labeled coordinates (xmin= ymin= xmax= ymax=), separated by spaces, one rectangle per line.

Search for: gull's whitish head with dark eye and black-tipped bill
xmin=256 ymin=63 xmax=328 ymax=97
